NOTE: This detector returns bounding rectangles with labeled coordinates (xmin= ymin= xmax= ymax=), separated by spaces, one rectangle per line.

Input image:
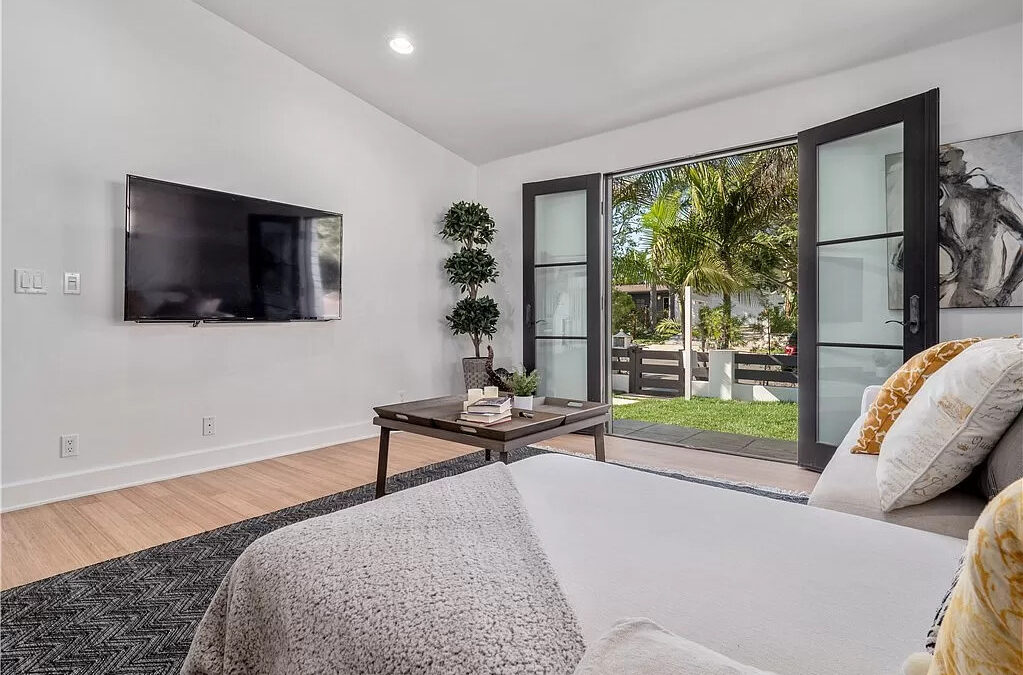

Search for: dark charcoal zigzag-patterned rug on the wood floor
xmin=0 ymin=448 xmax=806 ymax=675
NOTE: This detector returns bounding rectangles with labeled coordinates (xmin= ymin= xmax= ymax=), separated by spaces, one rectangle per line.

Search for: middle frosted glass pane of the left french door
xmin=535 ymin=265 xmax=586 ymax=338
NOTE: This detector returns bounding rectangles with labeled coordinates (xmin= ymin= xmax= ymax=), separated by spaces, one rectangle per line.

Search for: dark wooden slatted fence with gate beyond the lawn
xmin=611 ymin=345 xmax=798 ymax=396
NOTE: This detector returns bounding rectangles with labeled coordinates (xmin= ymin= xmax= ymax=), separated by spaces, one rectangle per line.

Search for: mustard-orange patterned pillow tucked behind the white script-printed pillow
xmin=852 ymin=338 xmax=981 ymax=455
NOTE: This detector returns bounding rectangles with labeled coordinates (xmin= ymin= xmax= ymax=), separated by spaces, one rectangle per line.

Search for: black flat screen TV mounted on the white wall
xmin=125 ymin=176 xmax=342 ymax=322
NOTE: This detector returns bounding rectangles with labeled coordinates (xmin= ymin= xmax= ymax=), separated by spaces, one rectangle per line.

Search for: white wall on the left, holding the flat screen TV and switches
xmin=2 ymin=0 xmax=477 ymax=508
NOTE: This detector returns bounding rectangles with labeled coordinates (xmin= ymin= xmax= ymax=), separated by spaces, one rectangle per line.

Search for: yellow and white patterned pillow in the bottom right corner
xmin=927 ymin=480 xmax=1023 ymax=675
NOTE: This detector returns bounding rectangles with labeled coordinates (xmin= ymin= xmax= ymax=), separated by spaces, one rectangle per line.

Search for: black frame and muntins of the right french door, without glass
xmin=798 ymin=89 xmax=939 ymax=470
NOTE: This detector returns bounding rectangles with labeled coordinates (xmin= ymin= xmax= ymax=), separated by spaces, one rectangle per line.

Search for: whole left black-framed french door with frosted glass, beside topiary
xmin=522 ymin=174 xmax=604 ymax=401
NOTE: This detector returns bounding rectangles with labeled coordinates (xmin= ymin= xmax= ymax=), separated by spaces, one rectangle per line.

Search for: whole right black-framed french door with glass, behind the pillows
xmin=798 ymin=89 xmax=939 ymax=470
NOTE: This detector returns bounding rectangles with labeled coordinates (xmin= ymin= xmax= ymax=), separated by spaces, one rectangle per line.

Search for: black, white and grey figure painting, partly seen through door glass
xmin=885 ymin=131 xmax=1023 ymax=310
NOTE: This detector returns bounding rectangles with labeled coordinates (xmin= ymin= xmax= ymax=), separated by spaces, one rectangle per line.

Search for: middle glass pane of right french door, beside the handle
xmin=817 ymin=237 xmax=902 ymax=345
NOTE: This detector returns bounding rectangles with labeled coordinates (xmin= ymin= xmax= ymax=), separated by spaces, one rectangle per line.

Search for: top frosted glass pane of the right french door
xmin=817 ymin=123 xmax=902 ymax=241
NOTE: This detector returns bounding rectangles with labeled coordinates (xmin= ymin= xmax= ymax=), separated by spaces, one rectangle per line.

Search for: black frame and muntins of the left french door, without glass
xmin=522 ymin=174 xmax=606 ymax=402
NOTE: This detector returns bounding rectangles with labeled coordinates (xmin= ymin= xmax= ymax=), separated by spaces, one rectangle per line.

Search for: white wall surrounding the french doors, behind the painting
xmin=479 ymin=25 xmax=1023 ymax=358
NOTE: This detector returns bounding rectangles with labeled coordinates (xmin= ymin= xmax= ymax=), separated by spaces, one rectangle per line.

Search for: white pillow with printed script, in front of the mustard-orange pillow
xmin=878 ymin=339 xmax=1023 ymax=511
